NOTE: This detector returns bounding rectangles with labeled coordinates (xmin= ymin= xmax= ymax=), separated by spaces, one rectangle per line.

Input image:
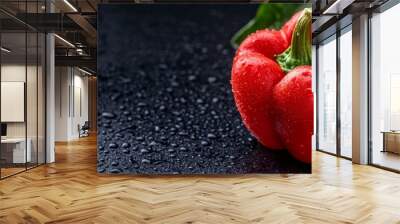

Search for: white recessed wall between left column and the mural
xmin=55 ymin=67 xmax=89 ymax=141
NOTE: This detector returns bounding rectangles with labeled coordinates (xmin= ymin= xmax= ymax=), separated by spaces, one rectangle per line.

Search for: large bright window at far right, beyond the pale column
xmin=371 ymin=4 xmax=400 ymax=170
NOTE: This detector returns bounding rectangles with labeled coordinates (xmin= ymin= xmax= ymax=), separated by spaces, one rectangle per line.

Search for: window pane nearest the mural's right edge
xmin=318 ymin=37 xmax=336 ymax=153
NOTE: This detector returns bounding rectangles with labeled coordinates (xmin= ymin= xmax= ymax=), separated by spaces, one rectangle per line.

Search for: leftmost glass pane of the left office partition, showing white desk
xmin=1 ymin=32 xmax=27 ymax=177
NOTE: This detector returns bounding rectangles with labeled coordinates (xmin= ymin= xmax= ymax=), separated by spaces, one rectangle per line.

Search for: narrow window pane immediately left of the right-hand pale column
xmin=340 ymin=27 xmax=353 ymax=158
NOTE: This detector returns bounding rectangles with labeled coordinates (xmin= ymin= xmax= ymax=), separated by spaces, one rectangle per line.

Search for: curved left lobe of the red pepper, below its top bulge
xmin=231 ymin=51 xmax=285 ymax=149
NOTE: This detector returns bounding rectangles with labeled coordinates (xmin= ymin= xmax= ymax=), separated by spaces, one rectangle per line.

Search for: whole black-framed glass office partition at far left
xmin=0 ymin=1 xmax=46 ymax=179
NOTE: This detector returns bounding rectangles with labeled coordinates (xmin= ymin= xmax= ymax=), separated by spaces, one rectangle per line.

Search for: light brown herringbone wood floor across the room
xmin=0 ymin=137 xmax=400 ymax=224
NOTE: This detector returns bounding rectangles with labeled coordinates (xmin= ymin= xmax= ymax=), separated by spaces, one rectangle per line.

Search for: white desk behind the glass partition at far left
xmin=1 ymin=138 xmax=32 ymax=163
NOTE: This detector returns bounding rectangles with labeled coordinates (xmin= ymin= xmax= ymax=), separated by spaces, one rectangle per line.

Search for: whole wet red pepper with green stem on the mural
xmin=231 ymin=9 xmax=313 ymax=160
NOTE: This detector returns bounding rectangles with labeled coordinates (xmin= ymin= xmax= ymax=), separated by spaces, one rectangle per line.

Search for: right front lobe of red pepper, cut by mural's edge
xmin=272 ymin=66 xmax=314 ymax=163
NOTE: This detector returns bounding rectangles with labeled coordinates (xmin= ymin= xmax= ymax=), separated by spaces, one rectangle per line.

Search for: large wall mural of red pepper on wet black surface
xmin=97 ymin=3 xmax=313 ymax=174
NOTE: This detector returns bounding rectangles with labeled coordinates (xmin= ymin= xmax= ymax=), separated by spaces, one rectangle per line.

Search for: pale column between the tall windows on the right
xmin=352 ymin=15 xmax=368 ymax=164
